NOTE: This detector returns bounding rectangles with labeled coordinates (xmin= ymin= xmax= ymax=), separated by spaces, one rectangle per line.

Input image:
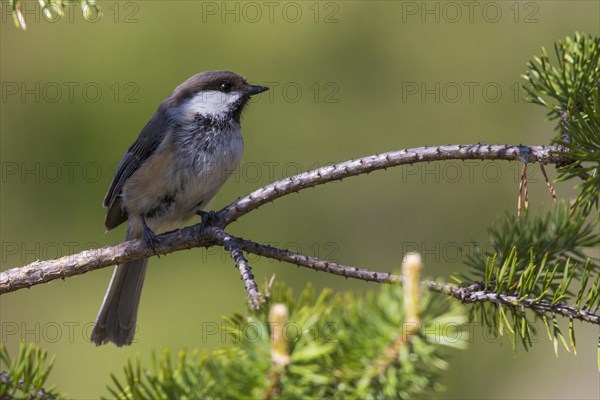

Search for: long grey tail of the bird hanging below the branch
xmin=91 ymin=230 xmax=148 ymax=347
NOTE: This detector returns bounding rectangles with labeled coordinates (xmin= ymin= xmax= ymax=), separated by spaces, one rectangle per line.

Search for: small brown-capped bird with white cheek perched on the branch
xmin=91 ymin=71 xmax=268 ymax=347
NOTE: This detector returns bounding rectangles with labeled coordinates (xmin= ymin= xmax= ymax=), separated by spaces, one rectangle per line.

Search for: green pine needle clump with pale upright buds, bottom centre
xmin=109 ymin=282 xmax=468 ymax=399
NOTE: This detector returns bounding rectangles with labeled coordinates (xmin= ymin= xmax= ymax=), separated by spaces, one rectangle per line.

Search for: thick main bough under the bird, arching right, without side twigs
xmin=0 ymin=144 xmax=566 ymax=295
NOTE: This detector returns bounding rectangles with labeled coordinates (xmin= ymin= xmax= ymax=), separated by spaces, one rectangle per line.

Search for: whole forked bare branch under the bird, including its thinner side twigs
xmin=0 ymin=144 xmax=600 ymax=325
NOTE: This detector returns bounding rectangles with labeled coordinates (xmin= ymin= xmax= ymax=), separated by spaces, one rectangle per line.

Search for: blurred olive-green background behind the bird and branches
xmin=0 ymin=0 xmax=600 ymax=399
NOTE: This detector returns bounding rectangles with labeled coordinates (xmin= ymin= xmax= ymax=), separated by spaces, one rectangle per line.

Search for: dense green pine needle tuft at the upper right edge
xmin=523 ymin=32 xmax=600 ymax=209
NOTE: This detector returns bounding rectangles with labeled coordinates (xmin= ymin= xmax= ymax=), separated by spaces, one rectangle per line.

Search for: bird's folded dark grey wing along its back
xmin=103 ymin=108 xmax=165 ymax=230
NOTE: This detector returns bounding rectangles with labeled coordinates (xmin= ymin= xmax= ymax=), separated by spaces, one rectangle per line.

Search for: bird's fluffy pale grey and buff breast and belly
xmin=122 ymin=124 xmax=244 ymax=232
